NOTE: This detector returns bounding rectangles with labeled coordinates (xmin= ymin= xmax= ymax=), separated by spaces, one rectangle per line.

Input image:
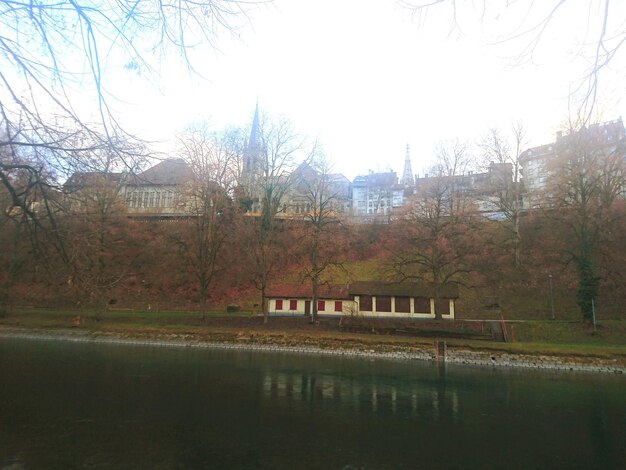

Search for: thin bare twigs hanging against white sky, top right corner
xmin=399 ymin=0 xmax=626 ymax=123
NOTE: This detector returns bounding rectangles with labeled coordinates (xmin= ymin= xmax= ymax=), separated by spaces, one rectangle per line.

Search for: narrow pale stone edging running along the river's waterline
xmin=0 ymin=328 xmax=626 ymax=374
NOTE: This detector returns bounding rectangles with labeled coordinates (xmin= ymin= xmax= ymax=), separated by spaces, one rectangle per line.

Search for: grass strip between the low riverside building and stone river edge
xmin=0 ymin=308 xmax=626 ymax=365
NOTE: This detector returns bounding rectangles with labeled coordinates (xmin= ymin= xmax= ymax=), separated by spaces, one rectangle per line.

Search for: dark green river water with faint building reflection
xmin=0 ymin=339 xmax=626 ymax=469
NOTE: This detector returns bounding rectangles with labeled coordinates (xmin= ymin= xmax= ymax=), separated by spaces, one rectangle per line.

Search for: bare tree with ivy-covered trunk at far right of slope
xmin=544 ymin=121 xmax=626 ymax=322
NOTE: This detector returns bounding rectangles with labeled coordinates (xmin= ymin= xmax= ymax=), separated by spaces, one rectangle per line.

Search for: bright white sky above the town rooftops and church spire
xmin=108 ymin=0 xmax=626 ymax=180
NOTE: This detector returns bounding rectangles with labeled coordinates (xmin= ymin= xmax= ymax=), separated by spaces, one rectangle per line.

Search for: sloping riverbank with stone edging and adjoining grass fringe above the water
xmin=0 ymin=325 xmax=626 ymax=374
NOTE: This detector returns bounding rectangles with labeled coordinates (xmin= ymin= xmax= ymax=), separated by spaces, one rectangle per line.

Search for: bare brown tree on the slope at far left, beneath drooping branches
xmin=0 ymin=123 xmax=147 ymax=308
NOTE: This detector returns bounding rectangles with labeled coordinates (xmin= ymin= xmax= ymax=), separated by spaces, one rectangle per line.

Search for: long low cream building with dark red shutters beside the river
xmin=267 ymin=282 xmax=458 ymax=319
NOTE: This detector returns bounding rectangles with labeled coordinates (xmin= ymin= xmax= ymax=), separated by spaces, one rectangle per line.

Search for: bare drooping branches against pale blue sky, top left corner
xmin=0 ymin=0 xmax=248 ymax=246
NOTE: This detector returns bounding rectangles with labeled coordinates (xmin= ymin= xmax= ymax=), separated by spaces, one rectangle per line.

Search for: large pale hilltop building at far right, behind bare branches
xmin=520 ymin=118 xmax=626 ymax=207
